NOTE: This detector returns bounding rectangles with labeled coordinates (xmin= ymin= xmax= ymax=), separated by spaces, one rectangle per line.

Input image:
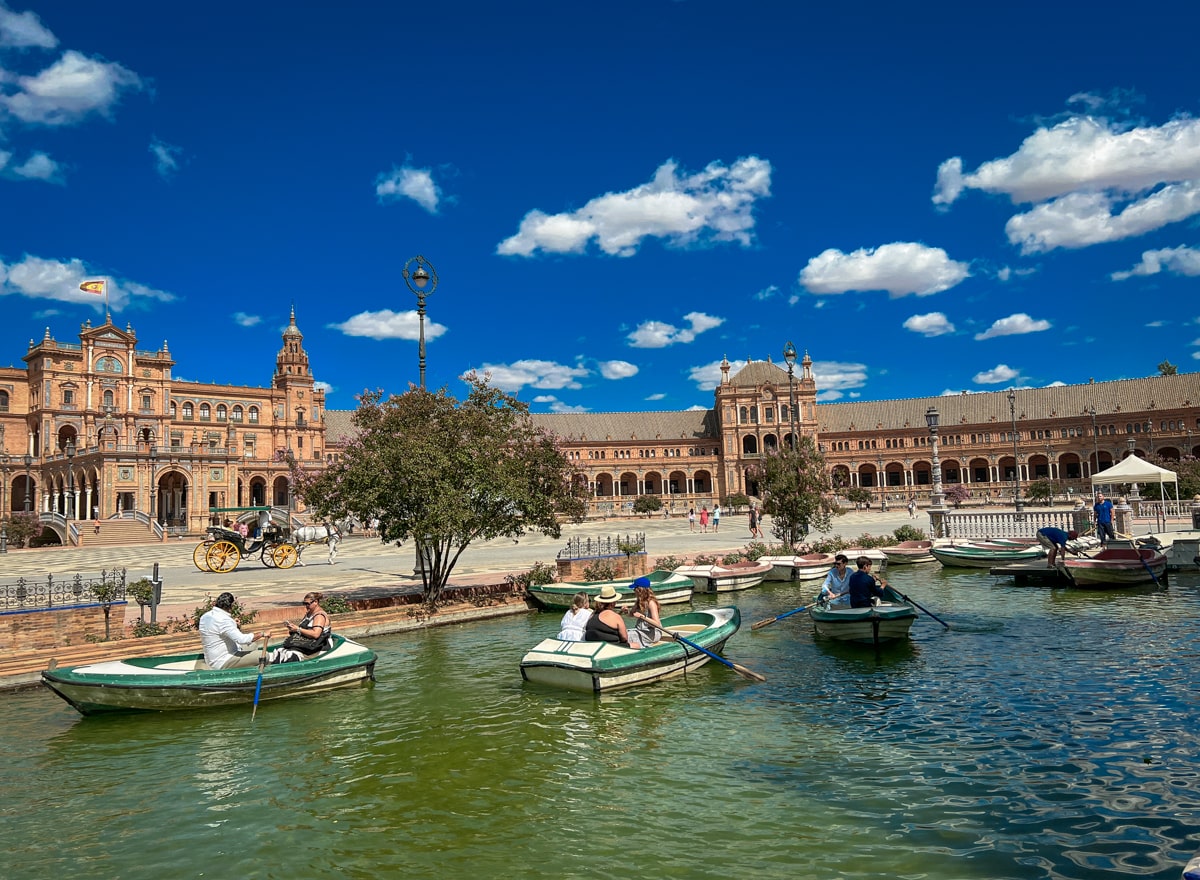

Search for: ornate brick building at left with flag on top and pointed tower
xmin=0 ymin=310 xmax=325 ymax=541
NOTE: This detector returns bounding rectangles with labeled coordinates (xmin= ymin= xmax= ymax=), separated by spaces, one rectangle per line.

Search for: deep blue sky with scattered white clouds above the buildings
xmin=0 ymin=0 xmax=1200 ymax=412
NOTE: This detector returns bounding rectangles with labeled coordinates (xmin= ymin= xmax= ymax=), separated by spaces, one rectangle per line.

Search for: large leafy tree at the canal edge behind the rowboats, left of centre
xmin=293 ymin=373 xmax=587 ymax=605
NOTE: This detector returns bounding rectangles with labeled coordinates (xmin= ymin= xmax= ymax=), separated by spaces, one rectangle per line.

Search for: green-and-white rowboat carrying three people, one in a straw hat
xmin=521 ymin=606 xmax=742 ymax=694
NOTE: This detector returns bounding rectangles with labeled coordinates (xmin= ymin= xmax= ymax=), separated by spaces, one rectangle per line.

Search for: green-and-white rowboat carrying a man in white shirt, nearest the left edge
xmin=42 ymin=634 xmax=376 ymax=716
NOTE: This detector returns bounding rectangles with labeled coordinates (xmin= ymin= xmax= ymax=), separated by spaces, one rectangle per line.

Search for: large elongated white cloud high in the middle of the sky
xmin=496 ymin=156 xmax=772 ymax=257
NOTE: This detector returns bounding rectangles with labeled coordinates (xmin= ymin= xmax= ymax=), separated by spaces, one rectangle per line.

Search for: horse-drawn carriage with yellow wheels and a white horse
xmin=192 ymin=507 xmax=341 ymax=574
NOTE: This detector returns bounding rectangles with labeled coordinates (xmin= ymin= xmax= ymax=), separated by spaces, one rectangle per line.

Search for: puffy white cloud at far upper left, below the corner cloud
xmin=0 ymin=49 xmax=142 ymax=125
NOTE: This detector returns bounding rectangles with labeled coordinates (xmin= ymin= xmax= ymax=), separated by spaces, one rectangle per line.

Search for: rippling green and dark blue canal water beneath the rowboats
xmin=0 ymin=565 xmax=1200 ymax=880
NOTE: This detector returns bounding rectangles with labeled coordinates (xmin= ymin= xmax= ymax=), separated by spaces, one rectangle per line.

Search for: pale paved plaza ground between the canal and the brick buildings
xmin=0 ymin=508 xmax=929 ymax=621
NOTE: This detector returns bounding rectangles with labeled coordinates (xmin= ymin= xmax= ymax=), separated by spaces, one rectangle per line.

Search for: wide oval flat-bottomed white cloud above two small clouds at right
xmin=799 ymin=241 xmax=971 ymax=297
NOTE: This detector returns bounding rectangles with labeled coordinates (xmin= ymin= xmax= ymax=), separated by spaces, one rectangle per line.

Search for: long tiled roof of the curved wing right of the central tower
xmin=817 ymin=373 xmax=1200 ymax=433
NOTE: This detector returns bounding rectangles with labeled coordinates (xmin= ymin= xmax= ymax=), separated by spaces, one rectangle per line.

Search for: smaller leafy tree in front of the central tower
xmin=755 ymin=437 xmax=838 ymax=547
